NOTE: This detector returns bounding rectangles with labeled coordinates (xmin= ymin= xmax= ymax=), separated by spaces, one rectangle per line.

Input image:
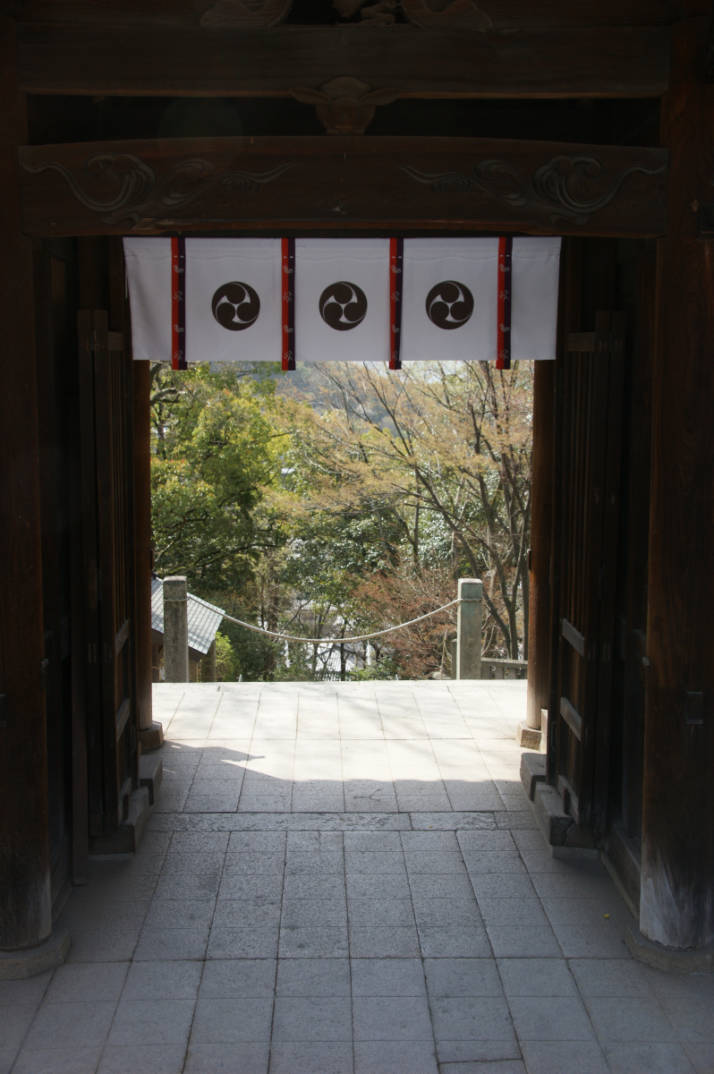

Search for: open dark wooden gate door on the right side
xmin=551 ymin=313 xmax=624 ymax=833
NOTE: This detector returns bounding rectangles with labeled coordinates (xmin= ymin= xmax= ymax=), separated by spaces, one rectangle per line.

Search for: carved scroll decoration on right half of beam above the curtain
xmin=403 ymin=155 xmax=666 ymax=224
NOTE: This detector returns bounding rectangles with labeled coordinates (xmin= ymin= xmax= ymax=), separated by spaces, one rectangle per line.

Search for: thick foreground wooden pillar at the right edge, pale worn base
xmin=640 ymin=18 xmax=714 ymax=950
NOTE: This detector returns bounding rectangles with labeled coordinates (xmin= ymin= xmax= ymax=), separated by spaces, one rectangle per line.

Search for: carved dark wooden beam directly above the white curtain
xmin=19 ymin=137 xmax=667 ymax=235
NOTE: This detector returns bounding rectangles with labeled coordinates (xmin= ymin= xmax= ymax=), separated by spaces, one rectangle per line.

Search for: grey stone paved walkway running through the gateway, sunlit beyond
xmin=0 ymin=682 xmax=714 ymax=1074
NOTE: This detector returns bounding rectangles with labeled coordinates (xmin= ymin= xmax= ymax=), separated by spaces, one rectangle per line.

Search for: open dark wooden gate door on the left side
xmin=78 ymin=310 xmax=137 ymax=839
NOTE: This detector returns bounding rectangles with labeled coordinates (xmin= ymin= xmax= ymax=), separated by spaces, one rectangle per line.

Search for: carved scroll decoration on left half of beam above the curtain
xmin=23 ymin=154 xmax=295 ymax=231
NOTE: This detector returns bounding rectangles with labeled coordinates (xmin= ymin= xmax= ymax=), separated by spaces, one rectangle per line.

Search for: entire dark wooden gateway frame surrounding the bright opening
xmin=0 ymin=0 xmax=714 ymax=972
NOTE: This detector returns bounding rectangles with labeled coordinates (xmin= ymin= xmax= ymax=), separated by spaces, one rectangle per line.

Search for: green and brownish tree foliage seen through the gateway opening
xmin=152 ymin=363 xmax=531 ymax=679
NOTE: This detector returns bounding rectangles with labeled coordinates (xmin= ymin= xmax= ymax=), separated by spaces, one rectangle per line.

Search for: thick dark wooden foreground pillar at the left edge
xmin=0 ymin=18 xmax=66 ymax=976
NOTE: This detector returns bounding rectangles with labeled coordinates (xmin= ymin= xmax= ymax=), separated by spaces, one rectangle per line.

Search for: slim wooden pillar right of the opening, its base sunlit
xmin=518 ymin=362 xmax=555 ymax=749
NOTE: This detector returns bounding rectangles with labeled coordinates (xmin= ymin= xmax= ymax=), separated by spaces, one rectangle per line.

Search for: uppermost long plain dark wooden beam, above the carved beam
xmin=20 ymin=24 xmax=669 ymax=98
